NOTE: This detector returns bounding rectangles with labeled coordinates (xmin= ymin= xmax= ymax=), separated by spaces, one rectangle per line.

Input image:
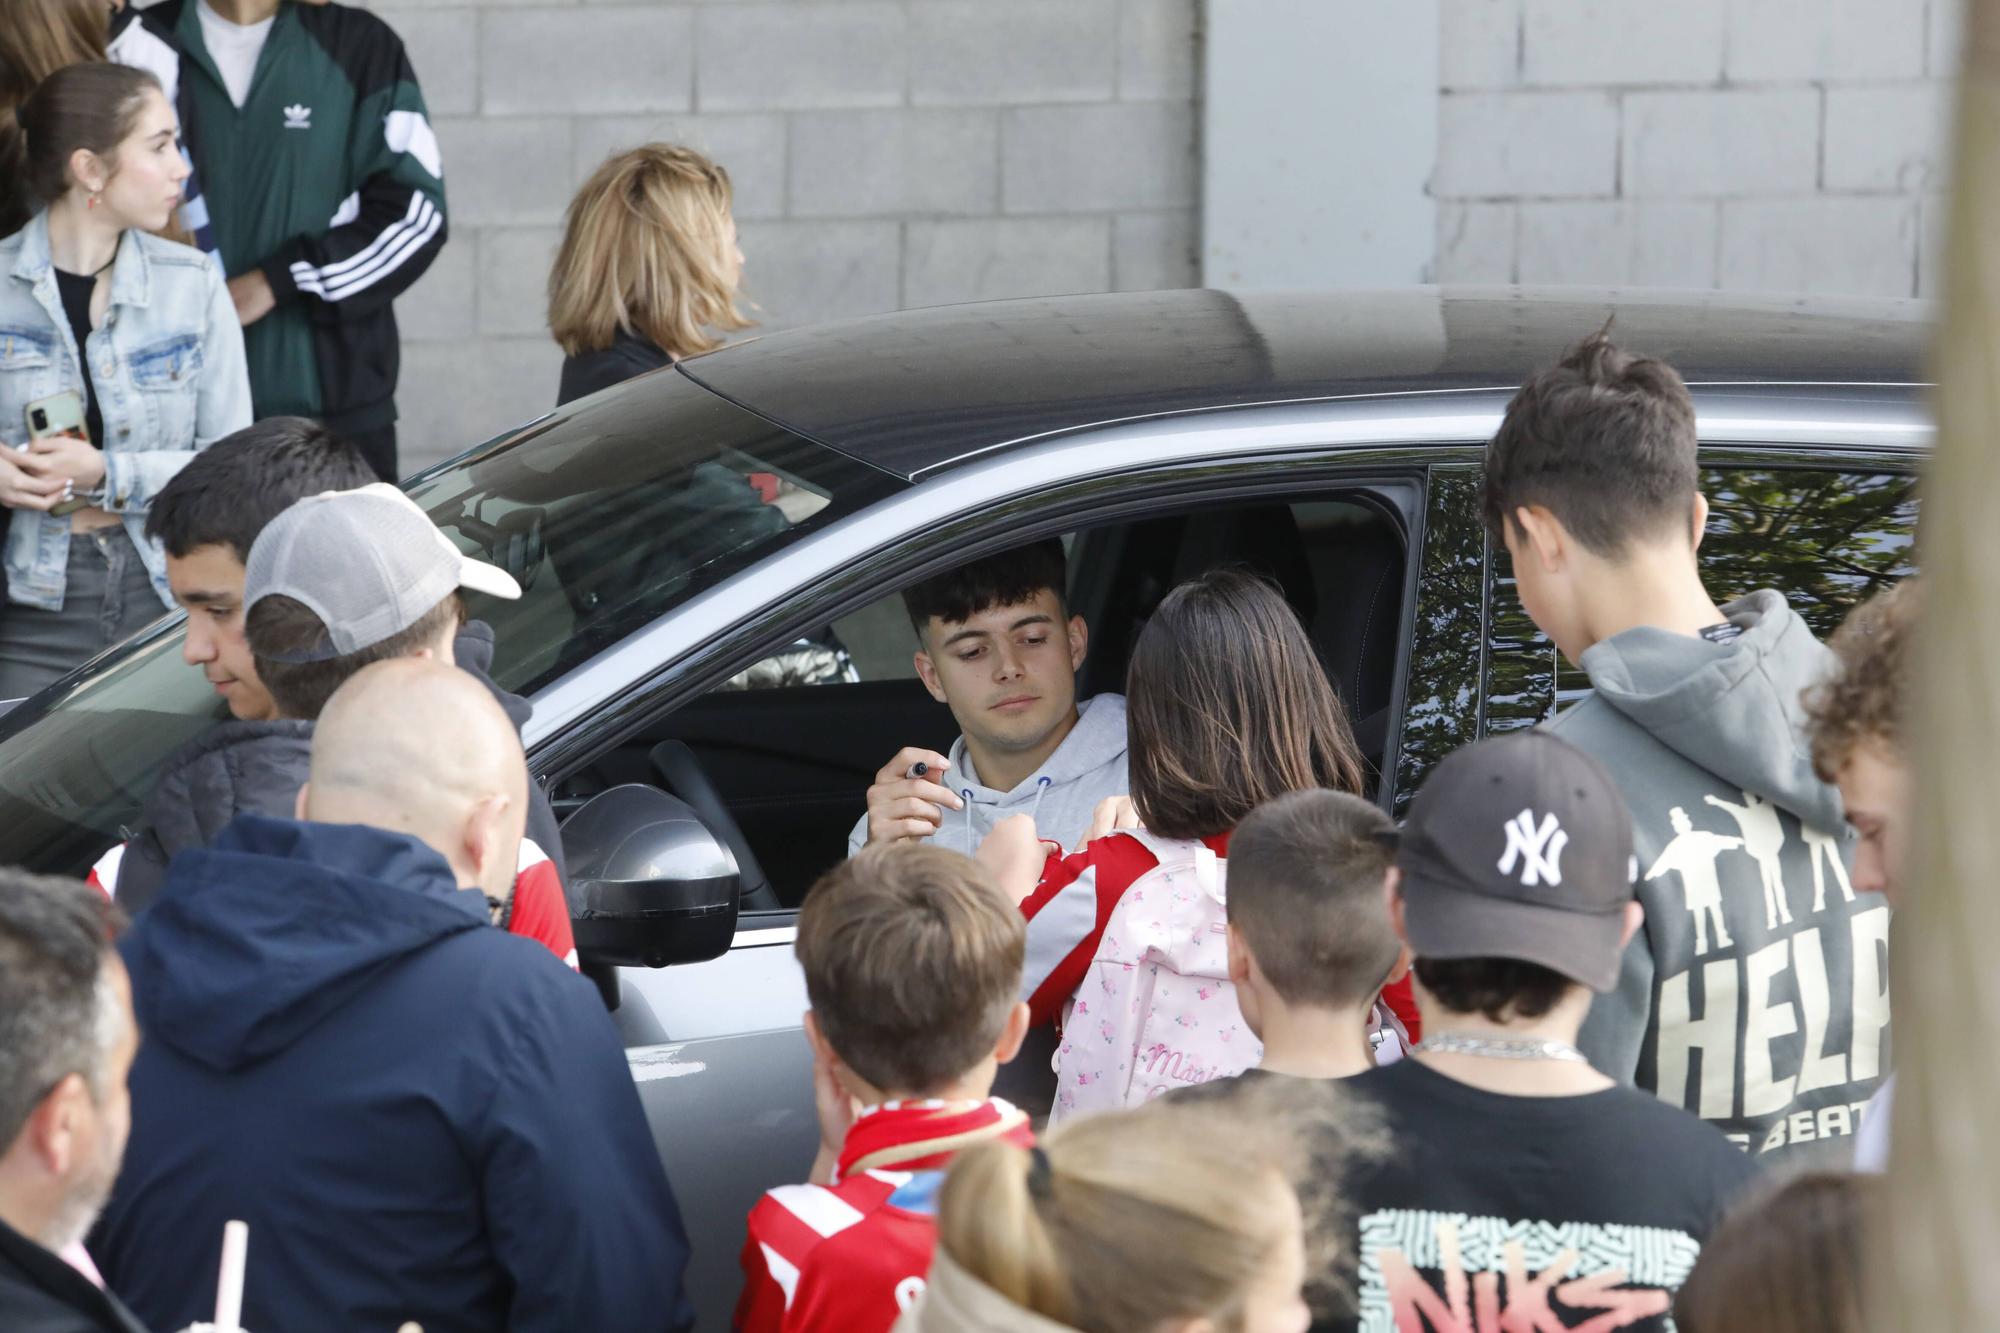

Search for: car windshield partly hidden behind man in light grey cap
xmin=0 ymin=372 xmax=896 ymax=875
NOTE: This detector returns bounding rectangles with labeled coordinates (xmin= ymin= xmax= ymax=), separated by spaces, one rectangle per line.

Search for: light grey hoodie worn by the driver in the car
xmin=848 ymin=695 xmax=1132 ymax=857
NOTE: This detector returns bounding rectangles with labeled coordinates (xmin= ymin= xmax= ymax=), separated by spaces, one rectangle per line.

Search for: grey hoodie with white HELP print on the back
xmin=1548 ymin=590 xmax=1888 ymax=1165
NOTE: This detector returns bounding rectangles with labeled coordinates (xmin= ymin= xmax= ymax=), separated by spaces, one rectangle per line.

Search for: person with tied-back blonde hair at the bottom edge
xmin=896 ymin=1089 xmax=1366 ymax=1333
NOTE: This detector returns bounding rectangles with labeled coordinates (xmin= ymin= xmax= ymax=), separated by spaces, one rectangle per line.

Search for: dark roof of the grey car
xmin=680 ymin=288 xmax=1930 ymax=478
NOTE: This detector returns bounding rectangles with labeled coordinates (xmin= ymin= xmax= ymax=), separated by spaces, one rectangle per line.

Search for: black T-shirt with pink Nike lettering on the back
xmin=1332 ymin=1059 xmax=1756 ymax=1333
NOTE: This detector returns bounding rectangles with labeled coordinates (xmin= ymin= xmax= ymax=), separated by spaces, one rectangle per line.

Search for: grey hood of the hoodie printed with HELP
xmin=1580 ymin=588 xmax=1842 ymax=829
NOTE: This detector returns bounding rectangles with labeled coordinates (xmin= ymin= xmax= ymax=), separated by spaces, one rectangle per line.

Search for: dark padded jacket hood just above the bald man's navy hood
xmin=146 ymin=719 xmax=312 ymax=857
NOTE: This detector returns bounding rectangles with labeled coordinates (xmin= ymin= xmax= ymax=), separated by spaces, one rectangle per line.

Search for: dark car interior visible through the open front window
xmin=556 ymin=490 xmax=1408 ymax=912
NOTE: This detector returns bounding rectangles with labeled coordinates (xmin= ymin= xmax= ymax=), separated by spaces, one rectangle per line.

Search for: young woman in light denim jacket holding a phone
xmin=0 ymin=64 xmax=250 ymax=699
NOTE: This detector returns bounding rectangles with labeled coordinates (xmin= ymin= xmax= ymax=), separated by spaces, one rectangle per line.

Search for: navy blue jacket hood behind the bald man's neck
xmin=124 ymin=815 xmax=488 ymax=1073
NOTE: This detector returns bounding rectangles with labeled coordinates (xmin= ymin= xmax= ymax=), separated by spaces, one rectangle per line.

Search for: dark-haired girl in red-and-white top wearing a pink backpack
xmin=978 ymin=568 xmax=1364 ymax=1088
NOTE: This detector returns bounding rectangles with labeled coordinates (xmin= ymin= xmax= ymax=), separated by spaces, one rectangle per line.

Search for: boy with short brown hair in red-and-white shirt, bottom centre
xmin=736 ymin=843 xmax=1032 ymax=1333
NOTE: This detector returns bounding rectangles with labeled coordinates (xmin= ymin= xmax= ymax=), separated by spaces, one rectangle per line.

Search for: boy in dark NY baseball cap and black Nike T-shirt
xmin=1334 ymin=731 xmax=1756 ymax=1331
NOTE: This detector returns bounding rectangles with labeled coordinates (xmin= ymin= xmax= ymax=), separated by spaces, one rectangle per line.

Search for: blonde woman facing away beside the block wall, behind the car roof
xmin=548 ymin=144 xmax=750 ymax=404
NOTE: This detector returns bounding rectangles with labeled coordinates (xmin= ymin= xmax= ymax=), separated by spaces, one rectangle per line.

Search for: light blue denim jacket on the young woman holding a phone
xmin=0 ymin=210 xmax=250 ymax=610
